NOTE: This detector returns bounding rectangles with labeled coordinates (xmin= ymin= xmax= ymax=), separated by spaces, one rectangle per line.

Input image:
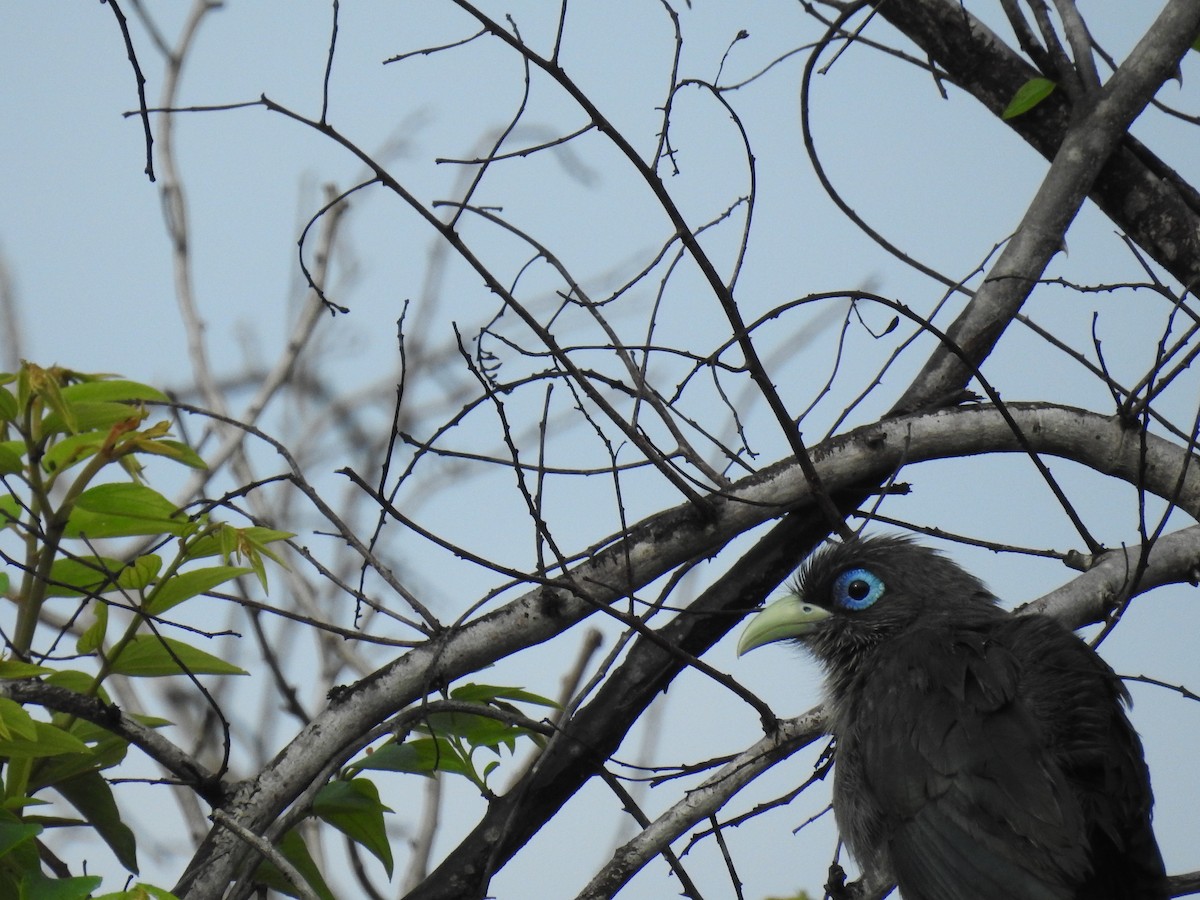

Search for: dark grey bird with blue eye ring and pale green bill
xmin=738 ymin=534 xmax=1169 ymax=900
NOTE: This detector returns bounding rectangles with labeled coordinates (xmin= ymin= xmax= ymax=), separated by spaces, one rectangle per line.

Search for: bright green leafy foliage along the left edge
xmin=0 ymin=362 xmax=288 ymax=900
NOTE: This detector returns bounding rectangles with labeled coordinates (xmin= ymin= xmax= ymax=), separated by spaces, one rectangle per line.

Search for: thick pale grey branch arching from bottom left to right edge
xmin=175 ymin=406 xmax=1200 ymax=900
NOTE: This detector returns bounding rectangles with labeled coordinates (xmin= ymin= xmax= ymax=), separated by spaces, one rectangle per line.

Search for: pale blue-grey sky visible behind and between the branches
xmin=0 ymin=0 xmax=1200 ymax=898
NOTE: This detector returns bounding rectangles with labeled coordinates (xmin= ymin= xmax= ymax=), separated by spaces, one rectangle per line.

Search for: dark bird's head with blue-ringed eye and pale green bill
xmin=738 ymin=536 xmax=995 ymax=667
